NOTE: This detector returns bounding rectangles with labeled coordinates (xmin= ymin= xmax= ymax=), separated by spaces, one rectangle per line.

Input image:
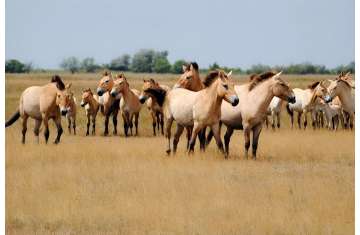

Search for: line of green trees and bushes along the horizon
xmin=5 ymin=49 xmax=355 ymax=74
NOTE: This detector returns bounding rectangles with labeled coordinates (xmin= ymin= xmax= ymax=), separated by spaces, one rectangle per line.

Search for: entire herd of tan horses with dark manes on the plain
xmin=5 ymin=62 xmax=355 ymax=159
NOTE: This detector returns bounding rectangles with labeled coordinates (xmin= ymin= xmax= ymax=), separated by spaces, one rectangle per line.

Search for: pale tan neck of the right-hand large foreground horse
xmin=250 ymin=79 xmax=274 ymax=112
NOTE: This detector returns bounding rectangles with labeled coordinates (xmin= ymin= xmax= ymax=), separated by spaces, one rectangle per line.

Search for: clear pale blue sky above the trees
xmin=5 ymin=0 xmax=355 ymax=69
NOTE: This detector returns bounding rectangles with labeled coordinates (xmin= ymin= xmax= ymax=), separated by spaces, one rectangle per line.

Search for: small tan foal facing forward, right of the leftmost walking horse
xmin=80 ymin=88 xmax=100 ymax=135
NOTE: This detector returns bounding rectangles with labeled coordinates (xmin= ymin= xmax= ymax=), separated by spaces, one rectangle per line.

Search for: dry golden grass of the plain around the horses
xmin=5 ymin=74 xmax=355 ymax=234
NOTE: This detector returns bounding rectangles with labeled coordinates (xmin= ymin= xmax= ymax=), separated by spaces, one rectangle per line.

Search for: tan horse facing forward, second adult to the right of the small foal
xmin=110 ymin=74 xmax=142 ymax=136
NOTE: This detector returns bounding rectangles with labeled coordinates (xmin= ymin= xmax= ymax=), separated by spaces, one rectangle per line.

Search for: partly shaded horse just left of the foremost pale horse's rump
xmin=139 ymin=79 xmax=170 ymax=136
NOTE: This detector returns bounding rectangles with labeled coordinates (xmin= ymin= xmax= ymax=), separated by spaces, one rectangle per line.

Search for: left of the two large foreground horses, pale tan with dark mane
xmin=164 ymin=70 xmax=239 ymax=157
